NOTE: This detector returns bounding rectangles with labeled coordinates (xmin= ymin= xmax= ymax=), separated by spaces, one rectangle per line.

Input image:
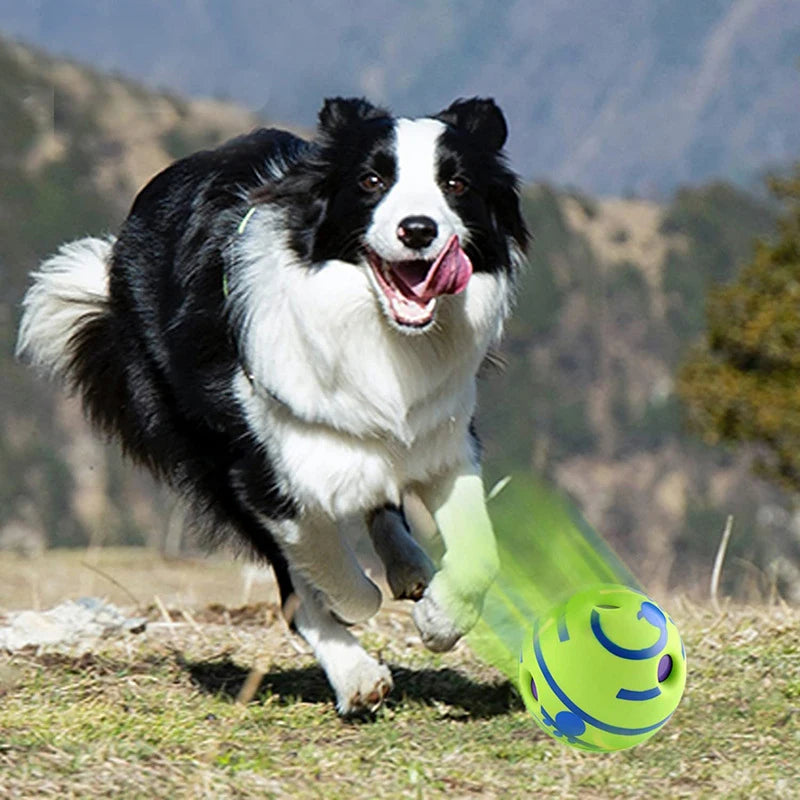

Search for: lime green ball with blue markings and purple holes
xmin=519 ymin=584 xmax=686 ymax=752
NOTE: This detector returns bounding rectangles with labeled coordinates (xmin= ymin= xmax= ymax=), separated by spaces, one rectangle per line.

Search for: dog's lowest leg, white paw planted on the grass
xmin=288 ymin=569 xmax=393 ymax=716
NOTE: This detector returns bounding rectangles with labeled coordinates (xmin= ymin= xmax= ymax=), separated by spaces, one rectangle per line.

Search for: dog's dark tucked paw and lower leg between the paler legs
xmin=369 ymin=506 xmax=436 ymax=600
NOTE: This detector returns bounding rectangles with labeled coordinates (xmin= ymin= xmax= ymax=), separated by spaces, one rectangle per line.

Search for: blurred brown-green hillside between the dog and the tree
xmin=479 ymin=184 xmax=800 ymax=597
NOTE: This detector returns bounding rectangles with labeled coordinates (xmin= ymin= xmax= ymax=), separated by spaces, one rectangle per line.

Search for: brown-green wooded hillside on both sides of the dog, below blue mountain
xmin=0 ymin=40 xmax=798 ymax=596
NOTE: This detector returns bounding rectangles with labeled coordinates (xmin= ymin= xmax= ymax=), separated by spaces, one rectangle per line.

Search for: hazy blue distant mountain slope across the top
xmin=0 ymin=0 xmax=800 ymax=197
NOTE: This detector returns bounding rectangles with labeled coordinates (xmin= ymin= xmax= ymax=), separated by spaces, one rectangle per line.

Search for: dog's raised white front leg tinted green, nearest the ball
xmin=413 ymin=468 xmax=499 ymax=651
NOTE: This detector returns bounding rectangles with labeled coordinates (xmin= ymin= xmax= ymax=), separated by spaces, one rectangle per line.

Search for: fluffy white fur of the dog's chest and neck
xmin=231 ymin=210 xmax=508 ymax=516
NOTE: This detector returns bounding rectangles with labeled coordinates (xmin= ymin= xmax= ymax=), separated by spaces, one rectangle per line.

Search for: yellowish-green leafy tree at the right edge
xmin=678 ymin=164 xmax=800 ymax=492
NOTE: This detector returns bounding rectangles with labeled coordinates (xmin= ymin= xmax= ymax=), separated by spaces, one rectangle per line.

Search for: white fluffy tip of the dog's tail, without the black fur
xmin=17 ymin=237 xmax=114 ymax=378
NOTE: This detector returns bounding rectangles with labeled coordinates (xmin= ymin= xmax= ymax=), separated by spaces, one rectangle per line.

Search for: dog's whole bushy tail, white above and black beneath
xmin=16 ymin=237 xmax=124 ymax=433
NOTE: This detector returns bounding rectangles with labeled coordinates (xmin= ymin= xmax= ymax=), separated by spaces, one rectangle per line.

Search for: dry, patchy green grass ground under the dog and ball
xmin=0 ymin=551 xmax=800 ymax=800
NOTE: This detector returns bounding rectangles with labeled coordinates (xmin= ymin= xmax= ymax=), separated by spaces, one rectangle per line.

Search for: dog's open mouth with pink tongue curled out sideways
xmin=367 ymin=234 xmax=472 ymax=328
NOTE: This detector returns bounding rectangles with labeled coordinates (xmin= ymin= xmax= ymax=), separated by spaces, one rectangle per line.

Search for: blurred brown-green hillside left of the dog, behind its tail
xmin=0 ymin=34 xmax=257 ymax=546
